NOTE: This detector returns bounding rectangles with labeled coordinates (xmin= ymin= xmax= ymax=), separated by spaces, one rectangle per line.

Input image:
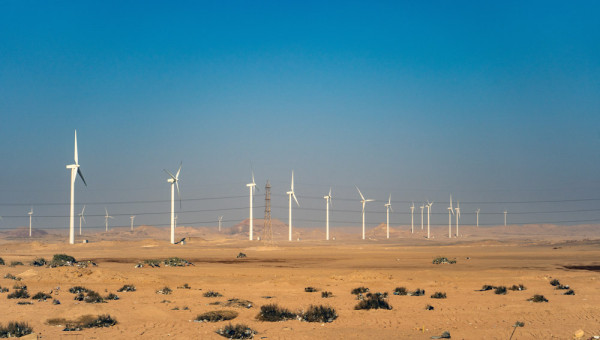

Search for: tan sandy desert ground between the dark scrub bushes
xmin=0 ymin=227 xmax=600 ymax=339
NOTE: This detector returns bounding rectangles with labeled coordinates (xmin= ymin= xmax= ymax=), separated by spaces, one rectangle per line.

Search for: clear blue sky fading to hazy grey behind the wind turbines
xmin=0 ymin=1 xmax=600 ymax=230
